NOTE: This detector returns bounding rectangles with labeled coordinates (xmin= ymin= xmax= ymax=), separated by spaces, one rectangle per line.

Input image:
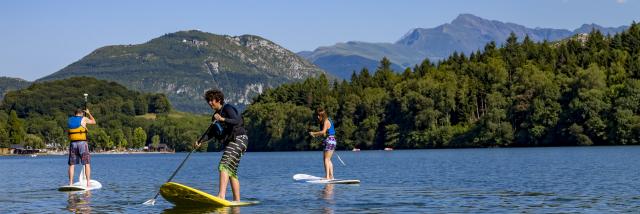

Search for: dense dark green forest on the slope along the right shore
xmin=243 ymin=22 xmax=640 ymax=150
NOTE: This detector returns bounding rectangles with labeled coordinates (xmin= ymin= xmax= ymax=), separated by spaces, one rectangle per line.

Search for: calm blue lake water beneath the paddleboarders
xmin=0 ymin=146 xmax=640 ymax=213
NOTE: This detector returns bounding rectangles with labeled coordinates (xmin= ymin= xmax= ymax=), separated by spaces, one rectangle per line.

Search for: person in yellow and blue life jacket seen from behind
xmin=68 ymin=109 xmax=96 ymax=187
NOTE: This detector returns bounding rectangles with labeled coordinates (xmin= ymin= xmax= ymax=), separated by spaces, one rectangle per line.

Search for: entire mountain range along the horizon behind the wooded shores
xmin=0 ymin=14 xmax=627 ymax=113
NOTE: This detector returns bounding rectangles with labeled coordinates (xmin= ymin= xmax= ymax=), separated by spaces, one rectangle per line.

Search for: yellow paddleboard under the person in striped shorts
xmin=160 ymin=182 xmax=259 ymax=207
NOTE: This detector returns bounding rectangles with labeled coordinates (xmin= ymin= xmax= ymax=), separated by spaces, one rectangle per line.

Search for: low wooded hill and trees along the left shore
xmin=0 ymin=77 xmax=219 ymax=151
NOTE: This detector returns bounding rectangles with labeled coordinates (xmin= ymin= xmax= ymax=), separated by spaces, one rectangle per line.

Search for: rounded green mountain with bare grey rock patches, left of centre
xmin=38 ymin=30 xmax=324 ymax=112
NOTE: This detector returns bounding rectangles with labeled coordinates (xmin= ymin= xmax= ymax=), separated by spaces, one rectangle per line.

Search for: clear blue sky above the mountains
xmin=0 ymin=0 xmax=640 ymax=81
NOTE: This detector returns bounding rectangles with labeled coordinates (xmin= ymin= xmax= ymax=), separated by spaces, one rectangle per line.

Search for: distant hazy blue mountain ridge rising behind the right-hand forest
xmin=299 ymin=14 xmax=627 ymax=77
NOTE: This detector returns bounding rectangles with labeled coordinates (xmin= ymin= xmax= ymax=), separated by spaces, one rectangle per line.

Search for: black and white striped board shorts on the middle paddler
xmin=218 ymin=135 xmax=249 ymax=179
